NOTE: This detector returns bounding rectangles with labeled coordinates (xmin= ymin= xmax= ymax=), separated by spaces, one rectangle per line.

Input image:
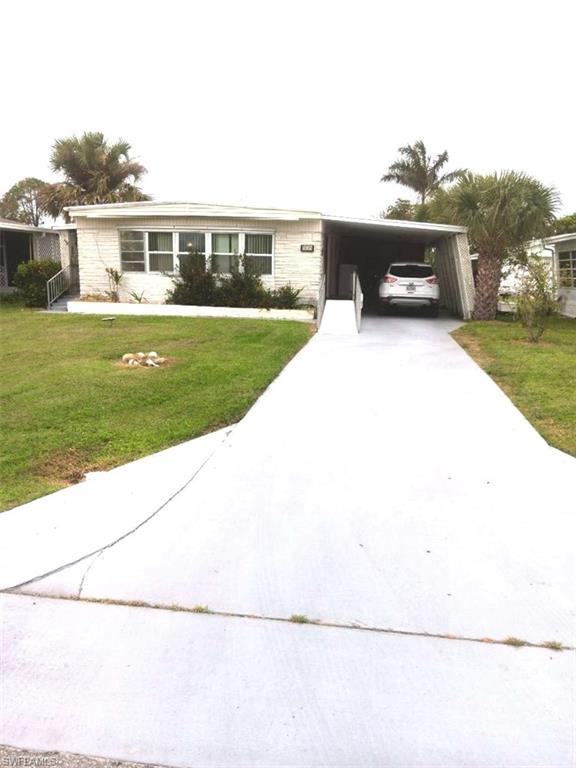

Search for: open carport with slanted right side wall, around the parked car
xmin=322 ymin=216 xmax=474 ymax=319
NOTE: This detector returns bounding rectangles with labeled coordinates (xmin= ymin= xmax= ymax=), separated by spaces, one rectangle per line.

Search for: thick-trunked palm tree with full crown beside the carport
xmin=440 ymin=171 xmax=560 ymax=320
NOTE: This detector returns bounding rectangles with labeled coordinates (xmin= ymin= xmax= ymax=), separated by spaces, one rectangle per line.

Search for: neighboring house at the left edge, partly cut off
xmin=0 ymin=219 xmax=61 ymax=292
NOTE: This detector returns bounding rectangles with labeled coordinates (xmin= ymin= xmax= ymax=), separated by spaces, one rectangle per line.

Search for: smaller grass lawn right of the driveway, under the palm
xmin=453 ymin=317 xmax=576 ymax=456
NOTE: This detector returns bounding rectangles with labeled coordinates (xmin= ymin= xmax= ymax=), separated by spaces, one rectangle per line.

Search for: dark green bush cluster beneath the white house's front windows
xmin=166 ymin=253 xmax=302 ymax=309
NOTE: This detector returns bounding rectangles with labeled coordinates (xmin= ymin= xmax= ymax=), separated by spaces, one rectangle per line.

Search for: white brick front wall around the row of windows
xmin=77 ymin=216 xmax=322 ymax=304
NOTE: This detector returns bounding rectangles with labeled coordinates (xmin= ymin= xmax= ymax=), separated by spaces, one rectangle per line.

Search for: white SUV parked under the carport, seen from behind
xmin=378 ymin=261 xmax=440 ymax=317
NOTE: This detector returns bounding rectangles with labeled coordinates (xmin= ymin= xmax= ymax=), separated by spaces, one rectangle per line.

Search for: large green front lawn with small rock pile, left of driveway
xmin=0 ymin=305 xmax=311 ymax=510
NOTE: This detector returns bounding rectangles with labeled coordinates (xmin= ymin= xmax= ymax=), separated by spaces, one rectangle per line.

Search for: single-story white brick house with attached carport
xmin=67 ymin=202 xmax=474 ymax=317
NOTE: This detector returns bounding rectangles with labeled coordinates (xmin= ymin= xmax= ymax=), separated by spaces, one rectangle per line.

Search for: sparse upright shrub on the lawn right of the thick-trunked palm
xmin=515 ymin=257 xmax=557 ymax=343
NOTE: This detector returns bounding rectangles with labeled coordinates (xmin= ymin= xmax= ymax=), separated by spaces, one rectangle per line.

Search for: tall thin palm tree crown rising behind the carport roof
xmin=380 ymin=140 xmax=465 ymax=204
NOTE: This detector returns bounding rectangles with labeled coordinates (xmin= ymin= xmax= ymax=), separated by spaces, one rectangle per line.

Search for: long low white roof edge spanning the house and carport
xmin=65 ymin=201 xmax=467 ymax=238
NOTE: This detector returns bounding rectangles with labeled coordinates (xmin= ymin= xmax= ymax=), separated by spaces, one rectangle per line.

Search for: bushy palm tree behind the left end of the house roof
xmin=44 ymin=133 xmax=150 ymax=218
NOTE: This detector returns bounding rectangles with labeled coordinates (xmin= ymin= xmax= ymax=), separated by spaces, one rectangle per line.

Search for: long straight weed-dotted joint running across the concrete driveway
xmin=9 ymin=590 xmax=576 ymax=651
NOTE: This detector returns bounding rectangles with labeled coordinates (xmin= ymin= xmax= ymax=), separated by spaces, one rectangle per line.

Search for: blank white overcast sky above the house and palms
xmin=0 ymin=0 xmax=576 ymax=216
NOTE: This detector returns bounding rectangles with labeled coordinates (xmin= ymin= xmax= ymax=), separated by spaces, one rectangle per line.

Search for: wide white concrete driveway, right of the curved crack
xmin=0 ymin=318 xmax=576 ymax=768
